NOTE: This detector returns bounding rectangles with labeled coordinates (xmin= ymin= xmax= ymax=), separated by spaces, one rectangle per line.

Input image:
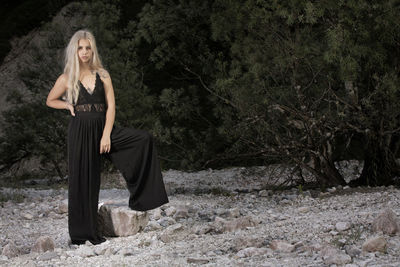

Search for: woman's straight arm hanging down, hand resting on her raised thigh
xmin=99 ymin=69 xmax=115 ymax=153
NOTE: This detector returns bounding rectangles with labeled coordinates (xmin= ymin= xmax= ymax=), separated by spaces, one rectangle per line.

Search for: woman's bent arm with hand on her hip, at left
xmin=46 ymin=74 xmax=75 ymax=116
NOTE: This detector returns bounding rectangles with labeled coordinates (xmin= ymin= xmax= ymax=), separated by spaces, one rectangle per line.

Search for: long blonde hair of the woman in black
xmin=64 ymin=29 xmax=103 ymax=104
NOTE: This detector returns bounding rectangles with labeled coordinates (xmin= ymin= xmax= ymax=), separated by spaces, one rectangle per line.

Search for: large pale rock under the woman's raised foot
xmin=99 ymin=204 xmax=149 ymax=236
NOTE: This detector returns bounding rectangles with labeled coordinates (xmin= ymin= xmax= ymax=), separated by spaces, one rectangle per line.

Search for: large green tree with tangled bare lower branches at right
xmin=212 ymin=0 xmax=400 ymax=187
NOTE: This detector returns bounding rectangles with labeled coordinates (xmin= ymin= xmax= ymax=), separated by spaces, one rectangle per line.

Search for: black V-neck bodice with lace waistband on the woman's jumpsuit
xmin=75 ymin=72 xmax=107 ymax=112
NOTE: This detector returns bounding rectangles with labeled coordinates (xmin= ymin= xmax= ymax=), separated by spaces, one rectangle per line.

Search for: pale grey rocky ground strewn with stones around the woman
xmin=0 ymin=164 xmax=400 ymax=266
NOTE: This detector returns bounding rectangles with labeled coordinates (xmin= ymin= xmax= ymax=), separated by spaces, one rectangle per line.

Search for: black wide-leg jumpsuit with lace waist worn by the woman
xmin=68 ymin=73 xmax=169 ymax=244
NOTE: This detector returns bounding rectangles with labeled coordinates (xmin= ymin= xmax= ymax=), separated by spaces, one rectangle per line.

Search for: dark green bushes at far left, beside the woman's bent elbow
xmin=0 ymin=24 xmax=68 ymax=177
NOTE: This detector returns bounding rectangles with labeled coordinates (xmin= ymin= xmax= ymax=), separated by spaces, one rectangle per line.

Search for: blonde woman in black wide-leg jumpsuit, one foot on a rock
xmin=46 ymin=30 xmax=169 ymax=244
